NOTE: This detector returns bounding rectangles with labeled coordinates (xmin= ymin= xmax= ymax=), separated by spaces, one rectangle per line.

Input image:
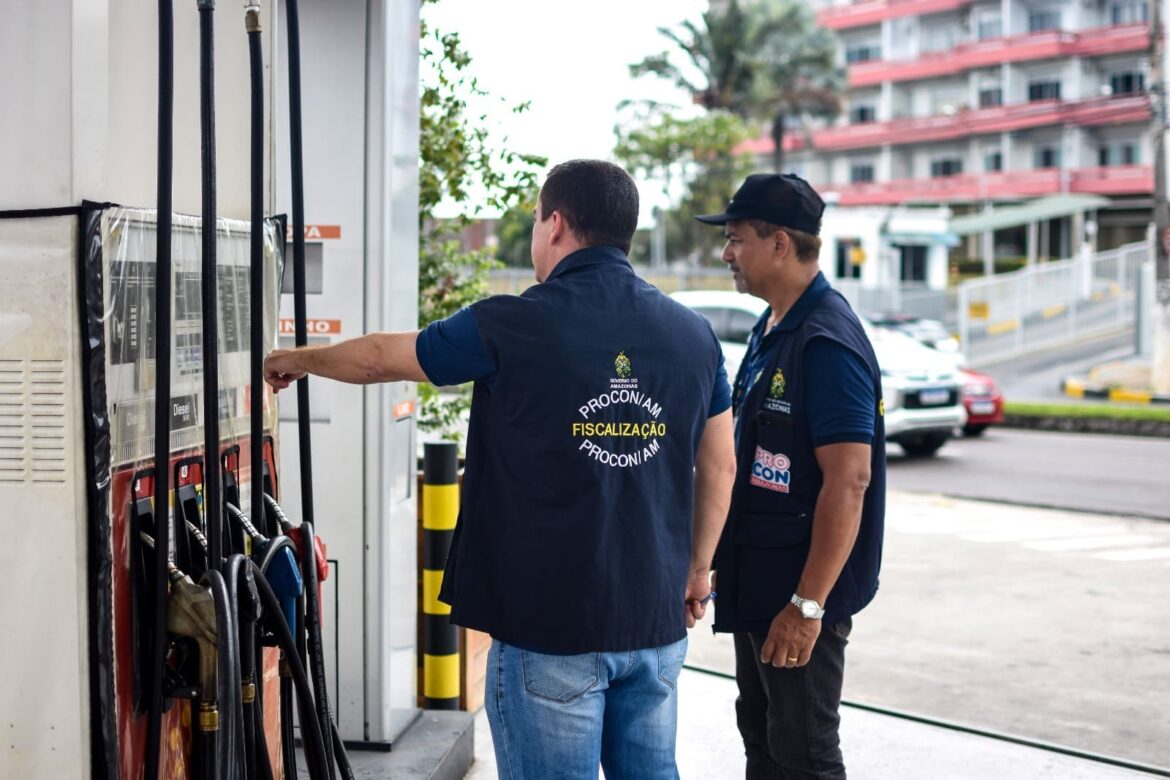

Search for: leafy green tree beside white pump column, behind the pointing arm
xmin=419 ymin=0 xmax=545 ymax=439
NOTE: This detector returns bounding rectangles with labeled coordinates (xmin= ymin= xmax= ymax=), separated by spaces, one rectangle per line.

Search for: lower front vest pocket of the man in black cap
xmin=735 ymin=512 xmax=812 ymax=621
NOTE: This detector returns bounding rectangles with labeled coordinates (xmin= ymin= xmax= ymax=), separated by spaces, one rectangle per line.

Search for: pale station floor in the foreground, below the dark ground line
xmin=466 ymin=669 xmax=1155 ymax=780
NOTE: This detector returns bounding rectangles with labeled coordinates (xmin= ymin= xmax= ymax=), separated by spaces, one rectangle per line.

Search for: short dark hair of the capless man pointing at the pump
xmin=541 ymin=160 xmax=638 ymax=255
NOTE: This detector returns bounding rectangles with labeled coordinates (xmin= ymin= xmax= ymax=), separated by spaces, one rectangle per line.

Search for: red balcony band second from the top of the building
xmin=849 ymin=25 xmax=1150 ymax=87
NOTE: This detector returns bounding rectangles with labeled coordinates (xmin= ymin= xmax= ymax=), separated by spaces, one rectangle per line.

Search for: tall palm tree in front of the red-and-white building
xmin=629 ymin=0 xmax=845 ymax=173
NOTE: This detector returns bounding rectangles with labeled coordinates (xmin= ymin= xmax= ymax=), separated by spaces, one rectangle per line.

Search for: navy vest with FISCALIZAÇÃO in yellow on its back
xmin=440 ymin=247 xmax=720 ymax=653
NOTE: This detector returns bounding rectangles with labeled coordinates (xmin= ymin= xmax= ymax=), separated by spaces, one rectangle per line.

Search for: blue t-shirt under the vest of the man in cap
xmin=736 ymin=322 xmax=878 ymax=447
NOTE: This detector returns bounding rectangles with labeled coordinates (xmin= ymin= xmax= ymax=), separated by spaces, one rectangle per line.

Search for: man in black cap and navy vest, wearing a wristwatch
xmin=697 ymin=174 xmax=886 ymax=779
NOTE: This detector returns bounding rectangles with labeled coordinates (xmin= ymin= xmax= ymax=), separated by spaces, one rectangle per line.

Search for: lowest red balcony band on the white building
xmin=818 ymin=165 xmax=1154 ymax=206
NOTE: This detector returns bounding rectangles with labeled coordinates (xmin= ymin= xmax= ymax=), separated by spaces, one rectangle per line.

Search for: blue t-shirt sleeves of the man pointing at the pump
xmin=414 ymin=309 xmax=731 ymax=417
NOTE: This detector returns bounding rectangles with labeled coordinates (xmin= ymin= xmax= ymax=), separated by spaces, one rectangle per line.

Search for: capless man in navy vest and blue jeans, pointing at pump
xmin=266 ymin=160 xmax=735 ymax=780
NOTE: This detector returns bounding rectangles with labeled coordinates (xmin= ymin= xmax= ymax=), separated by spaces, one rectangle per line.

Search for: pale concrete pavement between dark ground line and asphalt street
xmin=688 ymin=493 xmax=1170 ymax=776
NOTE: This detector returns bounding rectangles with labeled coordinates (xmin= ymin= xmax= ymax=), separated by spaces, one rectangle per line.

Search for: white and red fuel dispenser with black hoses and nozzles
xmin=0 ymin=0 xmax=418 ymax=780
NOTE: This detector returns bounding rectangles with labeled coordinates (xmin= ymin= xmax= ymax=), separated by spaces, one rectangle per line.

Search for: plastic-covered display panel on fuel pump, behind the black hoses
xmin=101 ymin=208 xmax=283 ymax=481
